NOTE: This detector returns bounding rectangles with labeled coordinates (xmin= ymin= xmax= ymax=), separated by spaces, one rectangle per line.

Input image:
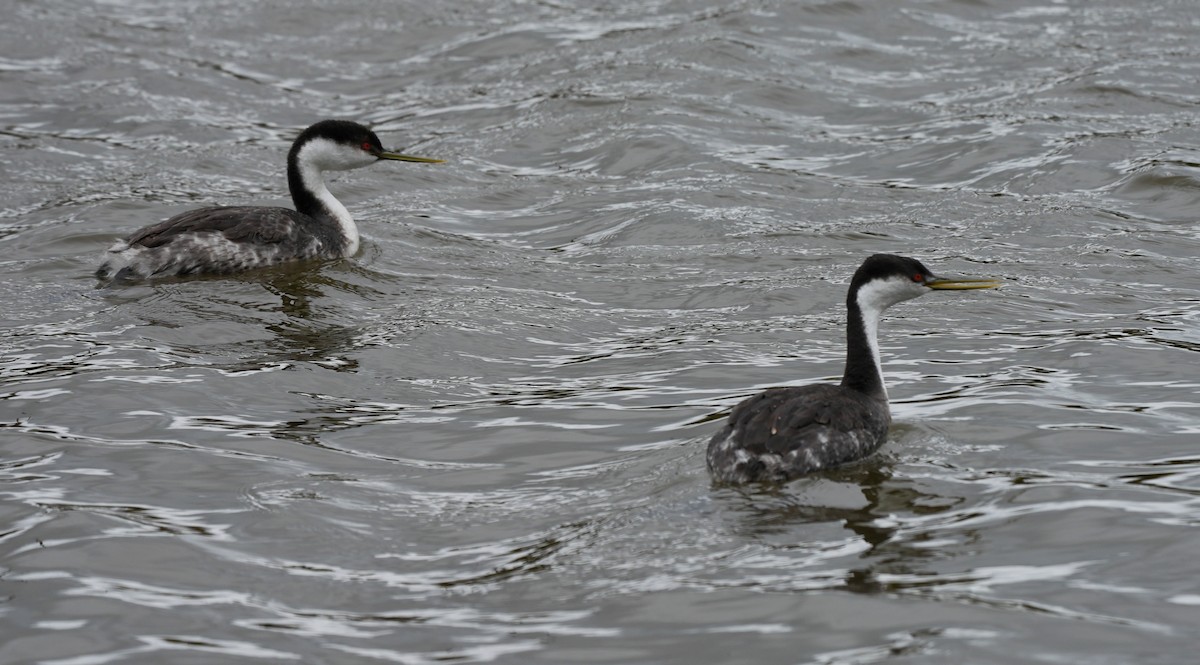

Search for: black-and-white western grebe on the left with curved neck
xmin=96 ymin=120 xmax=442 ymax=281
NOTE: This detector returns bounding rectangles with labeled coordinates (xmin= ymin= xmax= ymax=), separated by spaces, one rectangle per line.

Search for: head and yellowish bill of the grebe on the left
xmin=288 ymin=120 xmax=442 ymax=170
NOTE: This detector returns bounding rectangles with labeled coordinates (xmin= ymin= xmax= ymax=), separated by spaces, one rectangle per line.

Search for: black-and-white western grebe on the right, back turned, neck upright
xmin=707 ymin=254 xmax=1000 ymax=483
